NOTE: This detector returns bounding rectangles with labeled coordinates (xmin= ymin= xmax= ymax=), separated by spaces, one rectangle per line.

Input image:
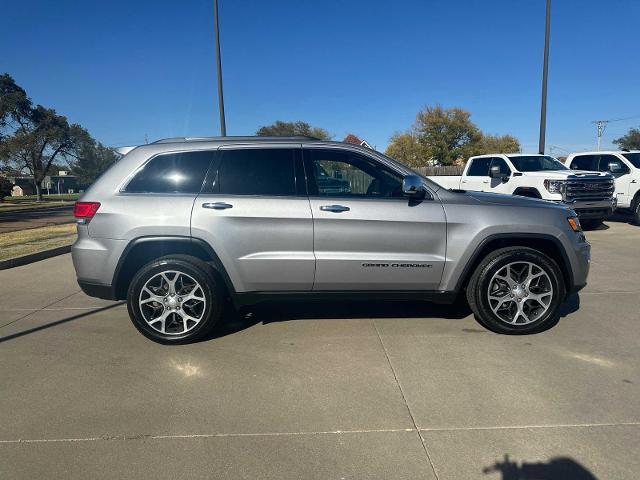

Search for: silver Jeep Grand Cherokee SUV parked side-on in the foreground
xmin=72 ymin=137 xmax=590 ymax=343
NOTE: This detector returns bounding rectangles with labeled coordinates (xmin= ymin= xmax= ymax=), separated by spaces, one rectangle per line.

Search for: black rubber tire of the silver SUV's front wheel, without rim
xmin=467 ymin=247 xmax=565 ymax=335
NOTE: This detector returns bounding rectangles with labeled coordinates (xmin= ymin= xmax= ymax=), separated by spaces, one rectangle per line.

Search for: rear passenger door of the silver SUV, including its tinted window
xmin=191 ymin=145 xmax=315 ymax=292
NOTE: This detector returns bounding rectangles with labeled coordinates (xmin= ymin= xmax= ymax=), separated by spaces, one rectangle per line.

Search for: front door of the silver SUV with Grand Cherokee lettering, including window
xmin=304 ymin=147 xmax=446 ymax=291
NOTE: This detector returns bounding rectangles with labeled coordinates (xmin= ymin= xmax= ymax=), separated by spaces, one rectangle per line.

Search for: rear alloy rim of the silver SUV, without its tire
xmin=138 ymin=270 xmax=207 ymax=335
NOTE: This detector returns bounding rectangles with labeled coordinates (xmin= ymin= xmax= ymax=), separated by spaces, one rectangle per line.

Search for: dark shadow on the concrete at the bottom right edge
xmin=482 ymin=455 xmax=597 ymax=480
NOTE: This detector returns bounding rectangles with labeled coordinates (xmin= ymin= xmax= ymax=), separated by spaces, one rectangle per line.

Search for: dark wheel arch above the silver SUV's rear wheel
xmin=111 ymin=236 xmax=235 ymax=300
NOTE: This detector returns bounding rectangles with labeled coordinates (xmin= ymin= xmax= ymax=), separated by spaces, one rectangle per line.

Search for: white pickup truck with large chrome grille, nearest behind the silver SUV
xmin=429 ymin=153 xmax=616 ymax=228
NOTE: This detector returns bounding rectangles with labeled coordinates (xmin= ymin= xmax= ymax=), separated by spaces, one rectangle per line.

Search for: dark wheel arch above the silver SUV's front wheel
xmin=455 ymin=233 xmax=573 ymax=292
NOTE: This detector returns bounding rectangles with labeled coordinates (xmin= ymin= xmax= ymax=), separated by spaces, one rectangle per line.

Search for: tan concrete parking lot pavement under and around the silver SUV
xmin=0 ymin=221 xmax=640 ymax=480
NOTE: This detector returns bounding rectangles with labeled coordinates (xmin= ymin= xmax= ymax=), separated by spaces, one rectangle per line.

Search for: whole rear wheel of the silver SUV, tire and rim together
xmin=127 ymin=255 xmax=224 ymax=345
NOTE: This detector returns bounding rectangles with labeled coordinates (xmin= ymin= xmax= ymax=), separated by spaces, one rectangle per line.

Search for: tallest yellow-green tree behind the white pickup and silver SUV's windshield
xmin=413 ymin=105 xmax=482 ymax=165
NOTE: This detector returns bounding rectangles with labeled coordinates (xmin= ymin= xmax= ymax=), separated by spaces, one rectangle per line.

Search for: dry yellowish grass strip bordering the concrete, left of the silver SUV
xmin=0 ymin=223 xmax=76 ymax=260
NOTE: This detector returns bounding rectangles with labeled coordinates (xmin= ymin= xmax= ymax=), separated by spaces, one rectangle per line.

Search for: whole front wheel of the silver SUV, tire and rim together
xmin=467 ymin=247 xmax=565 ymax=335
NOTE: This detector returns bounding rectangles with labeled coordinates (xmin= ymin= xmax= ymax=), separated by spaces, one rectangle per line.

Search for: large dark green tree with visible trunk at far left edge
xmin=0 ymin=74 xmax=91 ymax=200
